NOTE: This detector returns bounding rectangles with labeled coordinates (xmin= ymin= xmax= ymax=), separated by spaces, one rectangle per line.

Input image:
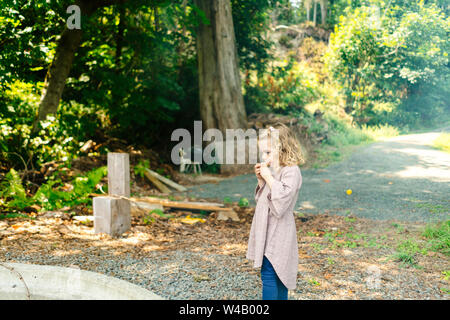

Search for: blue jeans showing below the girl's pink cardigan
xmin=261 ymin=256 xmax=288 ymax=300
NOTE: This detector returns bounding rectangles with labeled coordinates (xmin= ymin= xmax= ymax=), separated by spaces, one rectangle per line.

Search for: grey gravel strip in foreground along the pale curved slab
xmin=2 ymin=250 xmax=261 ymax=300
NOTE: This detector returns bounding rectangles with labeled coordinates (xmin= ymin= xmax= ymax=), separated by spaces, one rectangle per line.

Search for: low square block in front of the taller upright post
xmin=93 ymin=196 xmax=131 ymax=237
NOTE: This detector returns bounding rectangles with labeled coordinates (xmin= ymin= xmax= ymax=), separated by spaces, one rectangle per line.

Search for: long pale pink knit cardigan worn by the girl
xmin=246 ymin=165 xmax=302 ymax=289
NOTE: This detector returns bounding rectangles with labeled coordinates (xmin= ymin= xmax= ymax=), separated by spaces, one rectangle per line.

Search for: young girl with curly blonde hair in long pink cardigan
xmin=246 ymin=124 xmax=304 ymax=300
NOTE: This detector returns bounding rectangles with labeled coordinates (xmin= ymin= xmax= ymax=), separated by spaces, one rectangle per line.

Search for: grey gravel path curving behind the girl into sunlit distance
xmin=175 ymin=128 xmax=450 ymax=222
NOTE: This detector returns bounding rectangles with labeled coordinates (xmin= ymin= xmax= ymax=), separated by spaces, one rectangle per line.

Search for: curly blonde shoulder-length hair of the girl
xmin=260 ymin=122 xmax=305 ymax=166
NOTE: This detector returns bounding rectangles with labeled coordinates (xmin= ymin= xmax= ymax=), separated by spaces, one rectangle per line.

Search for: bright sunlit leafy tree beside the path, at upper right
xmin=325 ymin=1 xmax=450 ymax=124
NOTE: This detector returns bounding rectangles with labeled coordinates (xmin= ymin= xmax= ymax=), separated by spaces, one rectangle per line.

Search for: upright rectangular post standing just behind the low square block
xmin=108 ymin=152 xmax=130 ymax=198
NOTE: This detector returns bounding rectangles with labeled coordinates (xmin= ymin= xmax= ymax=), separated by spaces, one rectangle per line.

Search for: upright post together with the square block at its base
xmin=93 ymin=152 xmax=131 ymax=237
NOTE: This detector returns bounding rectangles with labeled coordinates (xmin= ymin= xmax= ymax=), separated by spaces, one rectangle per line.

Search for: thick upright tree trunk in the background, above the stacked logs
xmin=195 ymin=0 xmax=247 ymax=133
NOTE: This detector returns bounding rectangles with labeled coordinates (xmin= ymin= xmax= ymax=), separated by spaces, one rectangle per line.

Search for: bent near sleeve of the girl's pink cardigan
xmin=267 ymin=167 xmax=302 ymax=218
